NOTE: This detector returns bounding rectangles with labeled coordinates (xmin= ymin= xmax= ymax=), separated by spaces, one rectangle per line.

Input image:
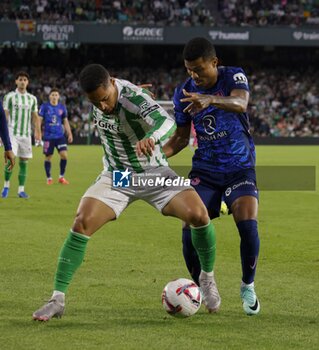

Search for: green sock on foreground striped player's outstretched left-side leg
xmin=54 ymin=230 xmax=90 ymax=293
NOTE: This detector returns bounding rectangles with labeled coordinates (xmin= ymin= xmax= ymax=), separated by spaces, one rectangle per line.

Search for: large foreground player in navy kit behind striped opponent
xmin=163 ymin=38 xmax=260 ymax=315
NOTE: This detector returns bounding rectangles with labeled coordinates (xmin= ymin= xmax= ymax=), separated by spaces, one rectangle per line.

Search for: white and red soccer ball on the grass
xmin=162 ymin=278 xmax=202 ymax=317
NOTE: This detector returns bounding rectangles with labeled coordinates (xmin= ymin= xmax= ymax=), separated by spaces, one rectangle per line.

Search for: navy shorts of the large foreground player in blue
xmin=189 ymin=168 xmax=258 ymax=219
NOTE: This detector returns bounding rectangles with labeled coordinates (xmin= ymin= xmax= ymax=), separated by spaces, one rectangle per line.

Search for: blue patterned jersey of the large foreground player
xmin=174 ymin=67 xmax=255 ymax=173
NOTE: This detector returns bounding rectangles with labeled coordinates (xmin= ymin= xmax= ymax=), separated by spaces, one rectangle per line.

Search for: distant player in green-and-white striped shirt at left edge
xmin=1 ymin=71 xmax=41 ymax=198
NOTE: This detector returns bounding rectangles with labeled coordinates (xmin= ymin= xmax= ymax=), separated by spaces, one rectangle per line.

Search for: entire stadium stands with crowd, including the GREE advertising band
xmin=0 ymin=0 xmax=319 ymax=144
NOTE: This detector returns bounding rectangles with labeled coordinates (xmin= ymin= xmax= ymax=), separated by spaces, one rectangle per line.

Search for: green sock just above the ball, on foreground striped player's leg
xmin=191 ymin=223 xmax=216 ymax=272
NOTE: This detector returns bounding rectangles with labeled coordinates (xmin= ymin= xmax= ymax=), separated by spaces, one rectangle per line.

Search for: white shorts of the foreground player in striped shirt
xmin=82 ymin=167 xmax=194 ymax=217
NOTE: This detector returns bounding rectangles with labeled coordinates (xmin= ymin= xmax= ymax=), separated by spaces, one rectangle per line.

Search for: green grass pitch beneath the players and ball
xmin=0 ymin=146 xmax=319 ymax=350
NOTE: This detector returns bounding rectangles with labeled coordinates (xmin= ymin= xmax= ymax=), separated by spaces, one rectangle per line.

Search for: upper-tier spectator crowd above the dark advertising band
xmin=0 ymin=0 xmax=319 ymax=26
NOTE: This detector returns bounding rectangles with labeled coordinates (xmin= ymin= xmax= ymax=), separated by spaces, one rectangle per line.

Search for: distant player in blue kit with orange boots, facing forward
xmin=39 ymin=89 xmax=73 ymax=185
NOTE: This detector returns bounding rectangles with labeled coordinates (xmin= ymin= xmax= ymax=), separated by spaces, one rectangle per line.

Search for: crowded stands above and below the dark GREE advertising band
xmin=0 ymin=0 xmax=319 ymax=142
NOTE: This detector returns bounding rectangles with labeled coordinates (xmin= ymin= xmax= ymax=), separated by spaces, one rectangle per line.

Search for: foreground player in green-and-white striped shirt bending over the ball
xmin=33 ymin=64 xmax=220 ymax=321
